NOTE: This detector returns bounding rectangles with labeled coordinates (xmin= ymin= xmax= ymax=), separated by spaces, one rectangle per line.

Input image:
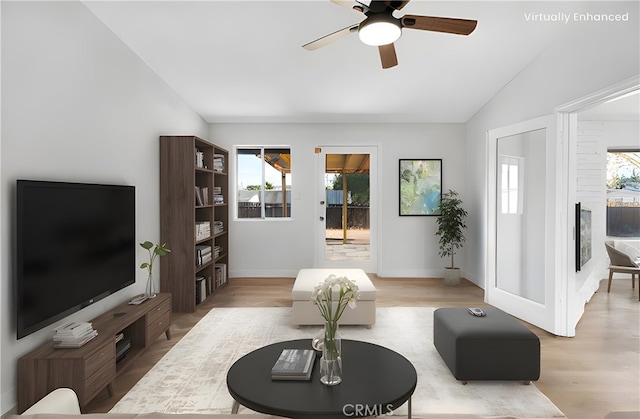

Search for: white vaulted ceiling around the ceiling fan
xmin=85 ymin=0 xmax=600 ymax=123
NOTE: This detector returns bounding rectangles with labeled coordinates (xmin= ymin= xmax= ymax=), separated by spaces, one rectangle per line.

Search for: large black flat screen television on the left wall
xmin=14 ymin=180 xmax=136 ymax=339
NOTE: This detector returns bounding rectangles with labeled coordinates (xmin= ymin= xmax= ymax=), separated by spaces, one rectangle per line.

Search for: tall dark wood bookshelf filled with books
xmin=160 ymin=136 xmax=229 ymax=313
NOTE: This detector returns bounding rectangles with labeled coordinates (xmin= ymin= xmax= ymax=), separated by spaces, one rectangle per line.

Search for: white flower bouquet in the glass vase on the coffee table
xmin=311 ymin=274 xmax=360 ymax=322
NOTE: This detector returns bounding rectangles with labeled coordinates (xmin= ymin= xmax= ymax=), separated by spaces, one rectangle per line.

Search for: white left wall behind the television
xmin=0 ymin=2 xmax=208 ymax=413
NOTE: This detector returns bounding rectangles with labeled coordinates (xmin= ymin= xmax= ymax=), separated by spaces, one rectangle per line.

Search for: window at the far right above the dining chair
xmin=607 ymin=150 xmax=640 ymax=237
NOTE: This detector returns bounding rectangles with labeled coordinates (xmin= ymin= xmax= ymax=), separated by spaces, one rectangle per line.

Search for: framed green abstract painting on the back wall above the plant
xmin=399 ymin=159 xmax=442 ymax=216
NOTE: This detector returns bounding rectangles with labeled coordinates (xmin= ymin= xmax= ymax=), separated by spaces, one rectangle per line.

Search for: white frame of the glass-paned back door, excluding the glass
xmin=314 ymin=145 xmax=380 ymax=273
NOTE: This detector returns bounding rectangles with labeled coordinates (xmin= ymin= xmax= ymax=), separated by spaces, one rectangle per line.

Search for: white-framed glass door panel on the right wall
xmin=485 ymin=116 xmax=564 ymax=334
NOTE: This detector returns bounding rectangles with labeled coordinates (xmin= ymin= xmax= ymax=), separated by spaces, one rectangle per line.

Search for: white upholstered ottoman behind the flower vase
xmin=291 ymin=269 xmax=376 ymax=327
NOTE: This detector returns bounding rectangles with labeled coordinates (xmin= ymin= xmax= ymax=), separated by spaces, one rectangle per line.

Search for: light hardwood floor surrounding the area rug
xmin=85 ymin=275 xmax=640 ymax=419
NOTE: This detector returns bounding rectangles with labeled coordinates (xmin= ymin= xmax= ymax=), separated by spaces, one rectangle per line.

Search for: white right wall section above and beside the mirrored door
xmin=464 ymin=2 xmax=640 ymax=292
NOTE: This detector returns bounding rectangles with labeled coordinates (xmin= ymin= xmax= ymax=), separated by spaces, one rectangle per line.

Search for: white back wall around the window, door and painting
xmin=209 ymin=124 xmax=466 ymax=277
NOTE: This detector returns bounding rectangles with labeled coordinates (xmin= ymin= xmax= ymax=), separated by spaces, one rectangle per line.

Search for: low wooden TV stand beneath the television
xmin=18 ymin=293 xmax=171 ymax=413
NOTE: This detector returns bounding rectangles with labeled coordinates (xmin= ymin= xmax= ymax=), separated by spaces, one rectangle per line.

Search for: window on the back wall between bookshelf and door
xmin=236 ymin=147 xmax=291 ymax=219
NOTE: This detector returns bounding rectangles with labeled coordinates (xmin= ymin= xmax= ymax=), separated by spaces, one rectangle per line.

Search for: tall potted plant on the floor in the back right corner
xmin=436 ymin=189 xmax=468 ymax=285
